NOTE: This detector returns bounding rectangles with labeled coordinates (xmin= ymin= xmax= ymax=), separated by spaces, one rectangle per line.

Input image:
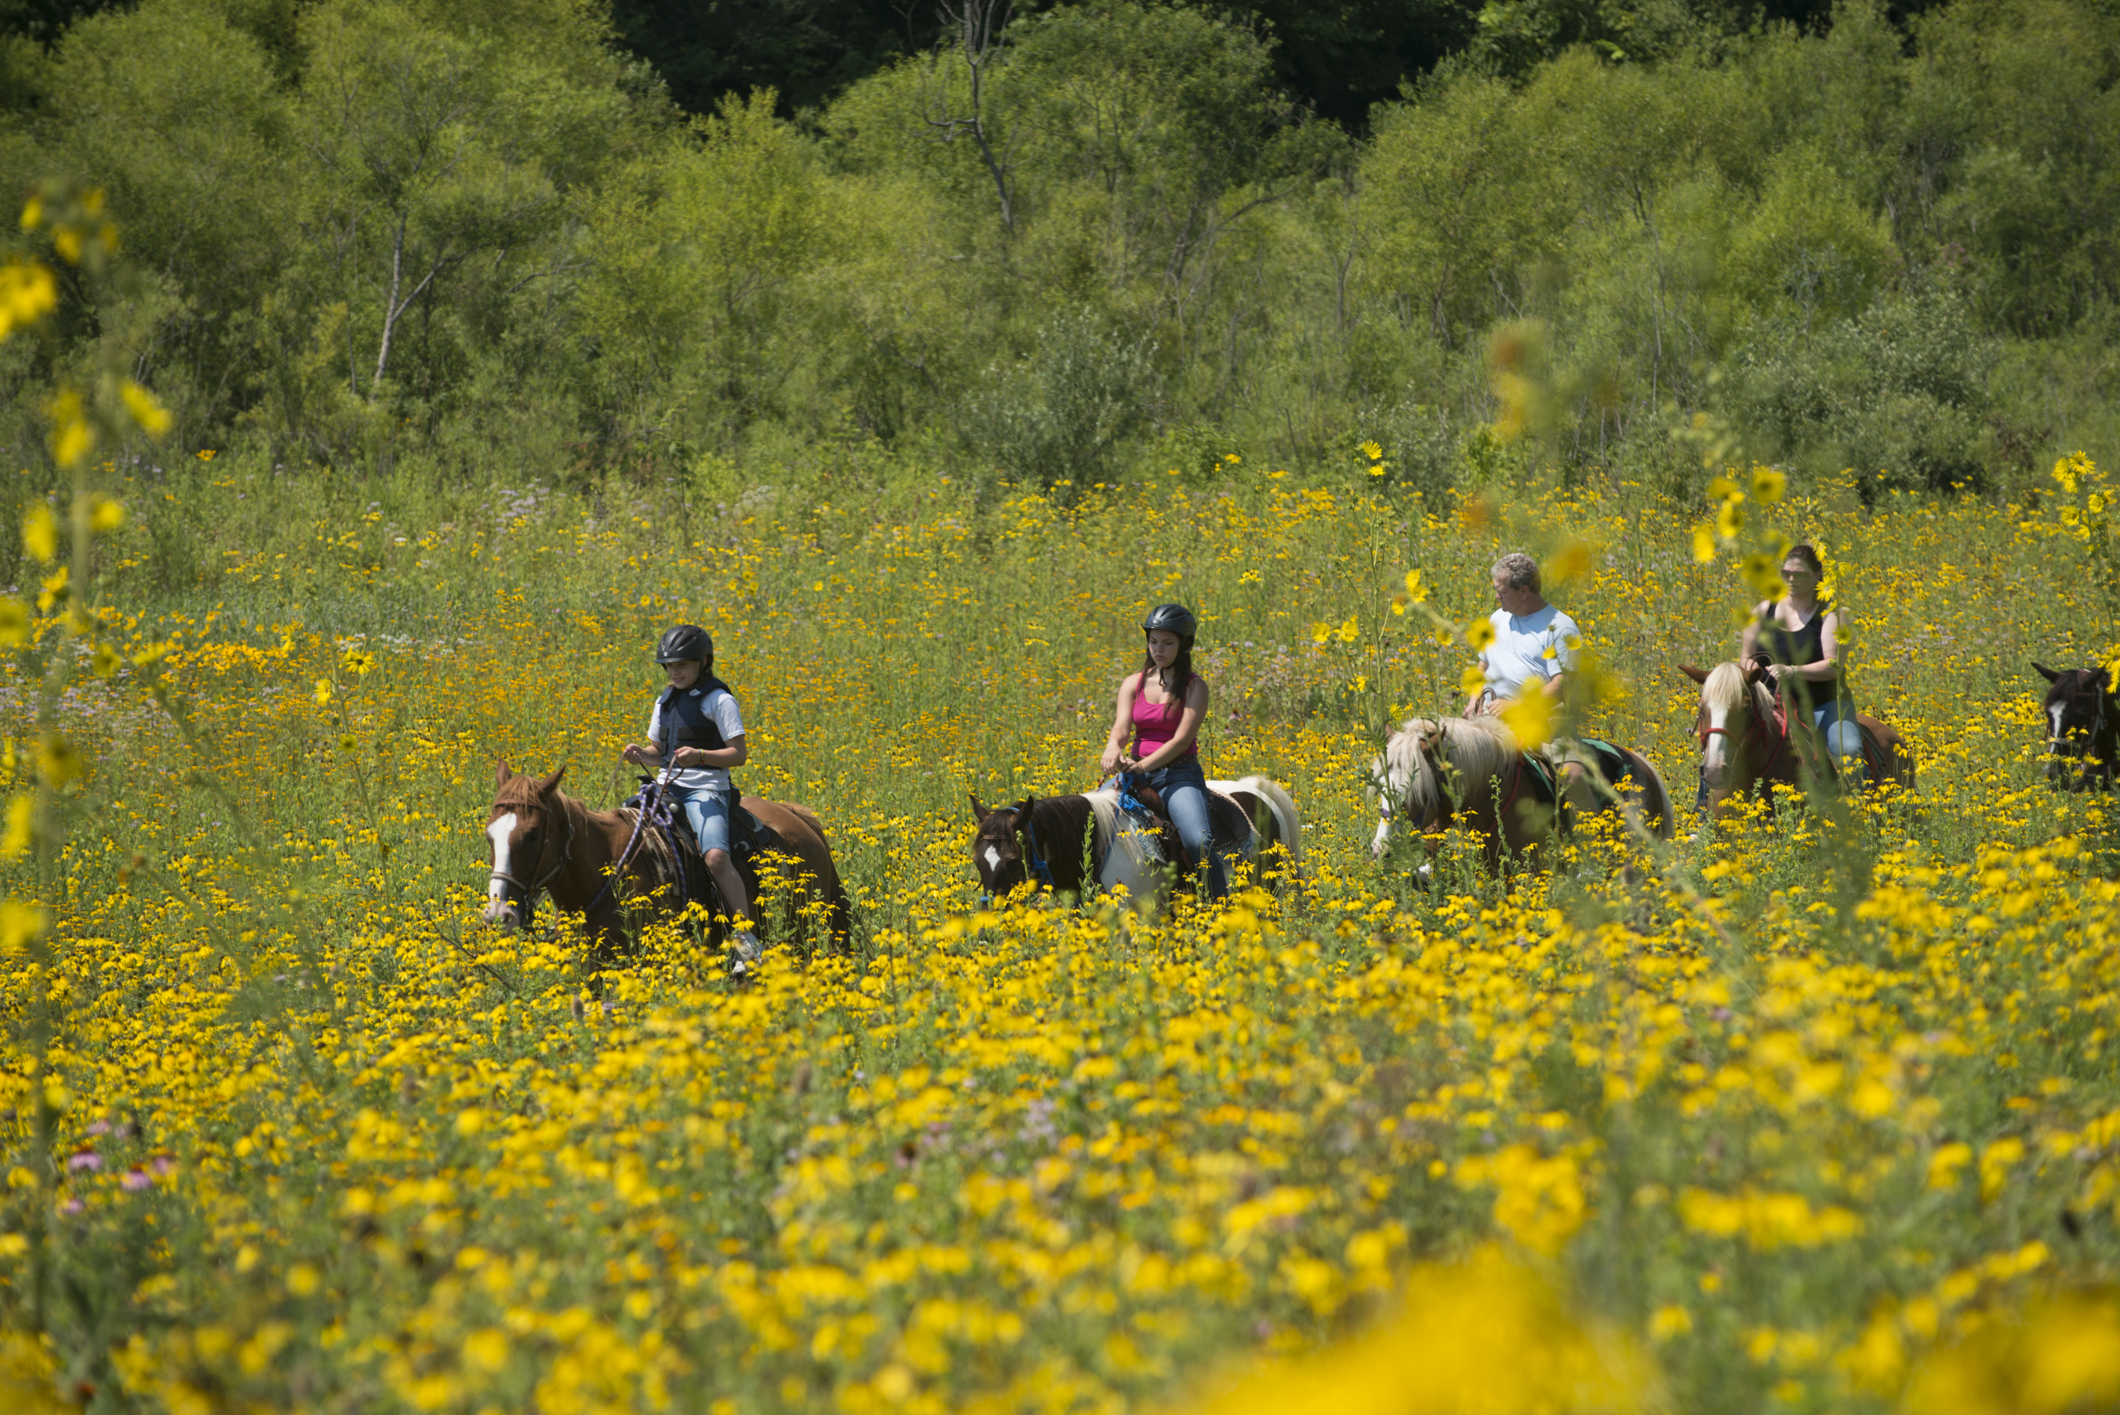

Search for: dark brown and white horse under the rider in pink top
xmin=971 ymin=776 xmax=1304 ymax=910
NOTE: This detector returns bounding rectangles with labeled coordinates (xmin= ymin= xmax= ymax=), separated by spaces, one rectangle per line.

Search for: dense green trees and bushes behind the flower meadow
xmin=0 ymin=0 xmax=2120 ymax=492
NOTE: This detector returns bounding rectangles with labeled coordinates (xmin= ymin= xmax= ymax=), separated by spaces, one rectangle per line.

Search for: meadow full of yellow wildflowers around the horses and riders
xmin=0 ymin=462 xmax=2120 ymax=1415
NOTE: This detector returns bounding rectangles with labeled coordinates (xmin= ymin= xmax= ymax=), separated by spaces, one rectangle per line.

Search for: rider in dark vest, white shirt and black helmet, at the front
xmin=625 ymin=624 xmax=759 ymax=974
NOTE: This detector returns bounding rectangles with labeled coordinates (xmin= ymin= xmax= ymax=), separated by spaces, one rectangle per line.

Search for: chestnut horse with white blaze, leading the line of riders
xmin=485 ymin=762 xmax=848 ymax=957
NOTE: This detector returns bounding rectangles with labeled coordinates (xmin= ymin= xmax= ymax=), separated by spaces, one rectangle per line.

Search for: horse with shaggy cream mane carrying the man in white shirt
xmin=1370 ymin=717 xmax=1675 ymax=868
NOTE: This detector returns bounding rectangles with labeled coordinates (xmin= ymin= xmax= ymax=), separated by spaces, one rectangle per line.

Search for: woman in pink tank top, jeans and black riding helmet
xmin=1102 ymin=605 xmax=1230 ymax=899
